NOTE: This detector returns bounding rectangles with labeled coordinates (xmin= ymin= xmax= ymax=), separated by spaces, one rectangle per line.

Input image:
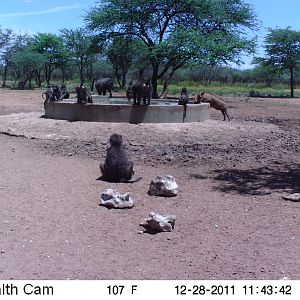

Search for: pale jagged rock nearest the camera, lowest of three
xmin=140 ymin=212 xmax=176 ymax=233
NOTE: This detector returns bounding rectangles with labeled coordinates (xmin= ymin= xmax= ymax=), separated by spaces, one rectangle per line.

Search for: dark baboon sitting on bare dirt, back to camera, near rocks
xmin=100 ymin=133 xmax=141 ymax=183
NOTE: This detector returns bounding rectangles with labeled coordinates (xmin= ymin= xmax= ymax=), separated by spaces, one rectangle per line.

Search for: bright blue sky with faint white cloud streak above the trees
xmin=0 ymin=0 xmax=300 ymax=67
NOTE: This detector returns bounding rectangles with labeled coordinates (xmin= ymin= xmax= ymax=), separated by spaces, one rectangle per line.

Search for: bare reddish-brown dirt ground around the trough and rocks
xmin=0 ymin=89 xmax=300 ymax=279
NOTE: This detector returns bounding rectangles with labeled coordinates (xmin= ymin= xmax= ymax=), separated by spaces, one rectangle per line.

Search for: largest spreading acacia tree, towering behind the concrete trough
xmin=85 ymin=0 xmax=256 ymax=97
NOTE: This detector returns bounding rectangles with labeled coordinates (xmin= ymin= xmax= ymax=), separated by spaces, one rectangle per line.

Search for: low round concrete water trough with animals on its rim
xmin=45 ymin=96 xmax=209 ymax=124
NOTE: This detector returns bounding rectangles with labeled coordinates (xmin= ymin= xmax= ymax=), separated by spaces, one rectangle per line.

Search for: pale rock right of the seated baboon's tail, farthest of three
xmin=148 ymin=175 xmax=178 ymax=197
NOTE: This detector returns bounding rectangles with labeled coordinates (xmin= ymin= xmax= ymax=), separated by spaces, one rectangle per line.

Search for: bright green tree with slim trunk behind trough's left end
xmin=30 ymin=33 xmax=68 ymax=85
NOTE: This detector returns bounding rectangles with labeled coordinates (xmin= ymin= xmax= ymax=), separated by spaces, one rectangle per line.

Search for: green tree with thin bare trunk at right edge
xmin=254 ymin=27 xmax=300 ymax=98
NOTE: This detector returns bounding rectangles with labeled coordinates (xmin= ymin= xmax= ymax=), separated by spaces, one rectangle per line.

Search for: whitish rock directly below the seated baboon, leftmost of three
xmin=100 ymin=189 xmax=134 ymax=208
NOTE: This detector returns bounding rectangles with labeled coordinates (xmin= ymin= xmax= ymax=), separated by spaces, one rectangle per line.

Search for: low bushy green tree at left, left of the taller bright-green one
xmin=11 ymin=50 xmax=46 ymax=89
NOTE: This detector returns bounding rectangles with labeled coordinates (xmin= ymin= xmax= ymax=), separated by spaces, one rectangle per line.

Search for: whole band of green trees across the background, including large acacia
xmin=0 ymin=0 xmax=300 ymax=97
